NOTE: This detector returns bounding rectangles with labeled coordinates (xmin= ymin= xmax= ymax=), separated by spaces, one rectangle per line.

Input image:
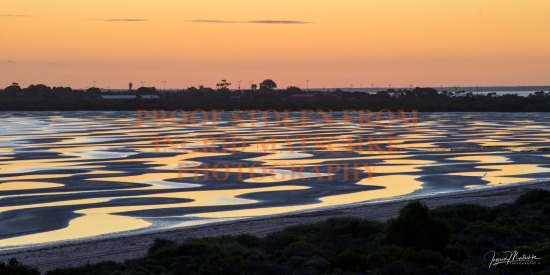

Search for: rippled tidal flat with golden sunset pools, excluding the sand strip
xmin=0 ymin=112 xmax=550 ymax=246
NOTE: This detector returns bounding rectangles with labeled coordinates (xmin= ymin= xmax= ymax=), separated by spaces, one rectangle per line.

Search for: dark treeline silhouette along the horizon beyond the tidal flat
xmin=0 ymin=79 xmax=550 ymax=112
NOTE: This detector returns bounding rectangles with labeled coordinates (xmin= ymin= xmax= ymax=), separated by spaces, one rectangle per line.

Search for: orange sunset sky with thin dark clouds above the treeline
xmin=0 ymin=0 xmax=550 ymax=88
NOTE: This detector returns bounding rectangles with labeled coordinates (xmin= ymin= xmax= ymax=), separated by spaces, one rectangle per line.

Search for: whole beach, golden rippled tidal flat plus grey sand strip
xmin=0 ymin=111 xmax=550 ymax=271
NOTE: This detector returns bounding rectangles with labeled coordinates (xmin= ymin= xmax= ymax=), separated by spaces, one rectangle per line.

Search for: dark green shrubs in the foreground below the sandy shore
xmin=4 ymin=190 xmax=550 ymax=275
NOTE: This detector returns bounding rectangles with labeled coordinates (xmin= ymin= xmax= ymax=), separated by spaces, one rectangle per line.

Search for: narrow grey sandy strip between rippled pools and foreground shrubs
xmin=0 ymin=182 xmax=550 ymax=271
